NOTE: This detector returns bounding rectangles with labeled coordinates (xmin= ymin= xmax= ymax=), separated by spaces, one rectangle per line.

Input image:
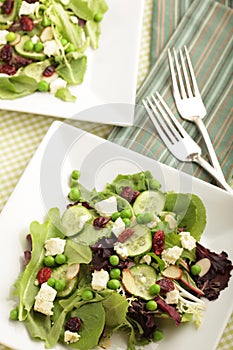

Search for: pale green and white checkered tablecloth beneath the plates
xmin=0 ymin=0 xmax=233 ymax=350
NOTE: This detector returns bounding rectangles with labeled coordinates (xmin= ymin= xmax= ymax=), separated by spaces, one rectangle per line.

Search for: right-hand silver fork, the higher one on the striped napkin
xmin=168 ymin=46 xmax=225 ymax=179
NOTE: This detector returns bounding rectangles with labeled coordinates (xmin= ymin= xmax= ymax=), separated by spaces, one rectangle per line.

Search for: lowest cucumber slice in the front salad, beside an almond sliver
xmin=122 ymin=264 xmax=157 ymax=300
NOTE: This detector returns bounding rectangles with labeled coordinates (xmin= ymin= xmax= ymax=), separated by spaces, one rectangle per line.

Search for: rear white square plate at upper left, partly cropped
xmin=0 ymin=0 xmax=144 ymax=126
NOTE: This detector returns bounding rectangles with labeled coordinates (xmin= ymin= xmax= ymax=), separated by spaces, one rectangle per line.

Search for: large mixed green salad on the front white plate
xmin=10 ymin=170 xmax=233 ymax=350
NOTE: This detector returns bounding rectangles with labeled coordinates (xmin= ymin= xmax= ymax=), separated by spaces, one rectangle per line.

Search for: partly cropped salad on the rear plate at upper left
xmin=0 ymin=0 xmax=108 ymax=102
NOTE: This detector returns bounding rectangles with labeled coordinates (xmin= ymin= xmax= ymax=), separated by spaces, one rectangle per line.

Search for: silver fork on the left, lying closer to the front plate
xmin=142 ymin=92 xmax=233 ymax=194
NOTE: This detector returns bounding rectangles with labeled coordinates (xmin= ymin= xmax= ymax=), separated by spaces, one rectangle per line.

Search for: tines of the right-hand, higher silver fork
xmin=168 ymin=46 xmax=200 ymax=98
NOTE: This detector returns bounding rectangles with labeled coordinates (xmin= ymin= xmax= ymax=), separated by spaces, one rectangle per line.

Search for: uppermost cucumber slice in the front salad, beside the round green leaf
xmin=133 ymin=190 xmax=165 ymax=215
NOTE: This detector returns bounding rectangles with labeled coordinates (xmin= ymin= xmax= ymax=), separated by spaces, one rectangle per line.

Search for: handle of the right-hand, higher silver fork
xmin=193 ymin=117 xmax=225 ymax=180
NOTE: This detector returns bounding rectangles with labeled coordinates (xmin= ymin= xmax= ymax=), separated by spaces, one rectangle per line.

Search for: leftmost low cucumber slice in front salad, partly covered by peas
xmin=51 ymin=264 xmax=78 ymax=298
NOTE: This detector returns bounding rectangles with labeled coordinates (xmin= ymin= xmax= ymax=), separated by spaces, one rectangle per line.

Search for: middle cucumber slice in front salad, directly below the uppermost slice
xmin=124 ymin=225 xmax=152 ymax=257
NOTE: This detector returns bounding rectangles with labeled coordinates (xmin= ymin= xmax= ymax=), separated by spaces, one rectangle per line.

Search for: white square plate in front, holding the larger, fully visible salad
xmin=0 ymin=122 xmax=233 ymax=350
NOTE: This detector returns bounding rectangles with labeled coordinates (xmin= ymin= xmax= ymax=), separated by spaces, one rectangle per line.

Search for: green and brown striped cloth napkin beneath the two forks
xmin=109 ymin=0 xmax=233 ymax=187
